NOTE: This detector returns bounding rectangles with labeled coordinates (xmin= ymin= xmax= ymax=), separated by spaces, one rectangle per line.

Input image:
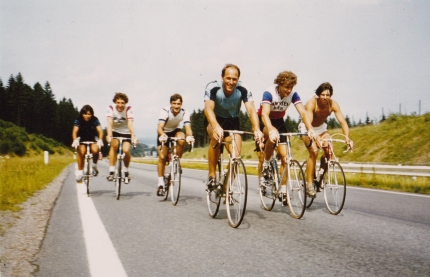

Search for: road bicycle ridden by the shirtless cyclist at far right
xmin=302 ymin=134 xmax=351 ymax=215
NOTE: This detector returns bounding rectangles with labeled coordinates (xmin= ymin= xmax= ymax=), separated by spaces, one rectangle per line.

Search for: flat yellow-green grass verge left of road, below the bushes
xmin=0 ymin=154 xmax=74 ymax=211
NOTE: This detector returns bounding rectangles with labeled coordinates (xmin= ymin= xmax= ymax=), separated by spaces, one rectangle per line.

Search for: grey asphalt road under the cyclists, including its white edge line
xmin=36 ymin=161 xmax=430 ymax=277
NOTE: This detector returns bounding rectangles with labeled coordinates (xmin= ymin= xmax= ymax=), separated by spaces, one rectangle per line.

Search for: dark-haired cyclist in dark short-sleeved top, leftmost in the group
xmin=72 ymin=105 xmax=103 ymax=183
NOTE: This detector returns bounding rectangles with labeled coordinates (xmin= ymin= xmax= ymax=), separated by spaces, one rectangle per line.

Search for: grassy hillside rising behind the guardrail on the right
xmin=184 ymin=113 xmax=430 ymax=165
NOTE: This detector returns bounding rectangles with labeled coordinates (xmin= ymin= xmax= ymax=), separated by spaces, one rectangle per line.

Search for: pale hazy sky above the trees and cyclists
xmin=0 ymin=0 xmax=430 ymax=144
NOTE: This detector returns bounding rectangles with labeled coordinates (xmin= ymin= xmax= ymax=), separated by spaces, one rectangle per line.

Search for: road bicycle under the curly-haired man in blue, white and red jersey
xmin=259 ymin=133 xmax=307 ymax=219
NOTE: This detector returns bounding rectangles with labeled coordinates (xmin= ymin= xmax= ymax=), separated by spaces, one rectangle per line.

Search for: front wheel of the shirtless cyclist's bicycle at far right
xmin=324 ymin=162 xmax=346 ymax=215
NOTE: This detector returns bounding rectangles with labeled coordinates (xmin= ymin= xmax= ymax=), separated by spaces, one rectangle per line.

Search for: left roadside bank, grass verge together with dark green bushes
xmin=0 ymin=121 xmax=73 ymax=211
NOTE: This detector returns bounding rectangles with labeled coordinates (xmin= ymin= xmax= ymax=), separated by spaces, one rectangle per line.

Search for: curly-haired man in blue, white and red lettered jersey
xmin=258 ymin=71 xmax=316 ymax=198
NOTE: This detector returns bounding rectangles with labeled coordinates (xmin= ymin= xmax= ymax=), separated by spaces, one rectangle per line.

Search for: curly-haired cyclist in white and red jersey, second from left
xmin=106 ymin=92 xmax=137 ymax=184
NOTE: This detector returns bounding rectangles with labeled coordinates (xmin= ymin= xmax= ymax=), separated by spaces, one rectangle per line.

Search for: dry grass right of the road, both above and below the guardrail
xmin=137 ymin=114 xmax=430 ymax=194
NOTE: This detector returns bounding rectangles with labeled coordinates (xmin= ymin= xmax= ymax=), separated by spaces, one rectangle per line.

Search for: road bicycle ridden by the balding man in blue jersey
xmin=206 ymin=130 xmax=254 ymax=228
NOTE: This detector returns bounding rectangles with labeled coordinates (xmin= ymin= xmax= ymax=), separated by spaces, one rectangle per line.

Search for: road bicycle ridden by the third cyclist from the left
xmin=161 ymin=137 xmax=193 ymax=206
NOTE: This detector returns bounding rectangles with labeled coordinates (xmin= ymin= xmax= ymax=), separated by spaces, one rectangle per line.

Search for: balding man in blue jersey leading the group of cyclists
xmin=204 ymin=64 xmax=262 ymax=189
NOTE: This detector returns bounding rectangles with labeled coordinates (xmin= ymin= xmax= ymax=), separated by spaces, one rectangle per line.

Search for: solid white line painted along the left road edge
xmin=76 ymin=184 xmax=127 ymax=277
